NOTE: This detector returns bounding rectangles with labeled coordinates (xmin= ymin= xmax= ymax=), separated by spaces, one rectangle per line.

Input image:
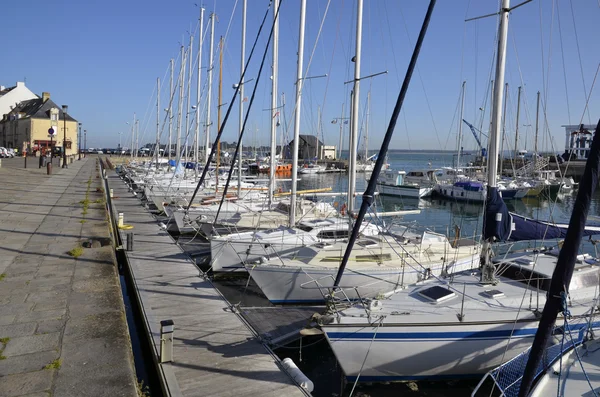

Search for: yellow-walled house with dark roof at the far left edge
xmin=0 ymin=92 xmax=78 ymax=156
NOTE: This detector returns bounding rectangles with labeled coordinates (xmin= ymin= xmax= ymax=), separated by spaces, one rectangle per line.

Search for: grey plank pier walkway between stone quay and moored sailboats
xmin=107 ymin=166 xmax=306 ymax=397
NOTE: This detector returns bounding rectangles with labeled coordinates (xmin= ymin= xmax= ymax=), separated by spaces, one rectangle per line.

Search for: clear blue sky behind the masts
xmin=0 ymin=0 xmax=600 ymax=152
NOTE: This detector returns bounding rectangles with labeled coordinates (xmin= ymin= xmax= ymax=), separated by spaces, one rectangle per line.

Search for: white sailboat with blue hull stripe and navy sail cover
xmin=320 ymin=0 xmax=600 ymax=381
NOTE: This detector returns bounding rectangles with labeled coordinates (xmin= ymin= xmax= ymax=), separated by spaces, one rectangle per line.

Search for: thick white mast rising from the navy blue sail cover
xmin=481 ymin=0 xmax=510 ymax=283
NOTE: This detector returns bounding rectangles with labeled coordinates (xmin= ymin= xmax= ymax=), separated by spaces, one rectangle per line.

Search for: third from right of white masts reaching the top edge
xmin=290 ymin=0 xmax=306 ymax=226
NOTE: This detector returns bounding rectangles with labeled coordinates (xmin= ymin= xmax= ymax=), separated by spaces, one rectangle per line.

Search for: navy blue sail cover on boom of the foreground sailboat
xmin=483 ymin=186 xmax=600 ymax=241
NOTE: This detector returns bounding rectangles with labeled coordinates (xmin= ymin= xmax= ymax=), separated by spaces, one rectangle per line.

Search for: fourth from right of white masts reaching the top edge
xmin=268 ymin=0 xmax=283 ymax=208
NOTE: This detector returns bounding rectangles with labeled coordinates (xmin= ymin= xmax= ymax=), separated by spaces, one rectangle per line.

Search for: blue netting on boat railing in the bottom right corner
xmin=471 ymin=324 xmax=587 ymax=397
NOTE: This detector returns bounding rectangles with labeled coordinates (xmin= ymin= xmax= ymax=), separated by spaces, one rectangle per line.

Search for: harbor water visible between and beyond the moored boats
xmin=173 ymin=150 xmax=600 ymax=397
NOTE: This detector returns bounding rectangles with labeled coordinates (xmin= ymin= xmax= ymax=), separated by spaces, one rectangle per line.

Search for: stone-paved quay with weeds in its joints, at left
xmin=0 ymin=157 xmax=138 ymax=397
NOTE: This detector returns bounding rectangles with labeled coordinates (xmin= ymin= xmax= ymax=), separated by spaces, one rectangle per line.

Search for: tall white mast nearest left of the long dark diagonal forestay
xmin=348 ymin=0 xmax=363 ymax=214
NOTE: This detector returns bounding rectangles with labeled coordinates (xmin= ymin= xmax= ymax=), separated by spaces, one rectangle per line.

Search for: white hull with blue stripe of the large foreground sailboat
xmin=322 ymin=316 xmax=539 ymax=382
